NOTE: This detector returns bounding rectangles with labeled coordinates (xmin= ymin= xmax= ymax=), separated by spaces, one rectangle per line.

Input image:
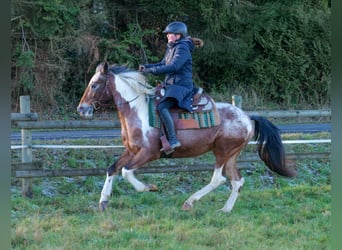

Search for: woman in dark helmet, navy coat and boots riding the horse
xmin=139 ymin=22 xmax=195 ymax=154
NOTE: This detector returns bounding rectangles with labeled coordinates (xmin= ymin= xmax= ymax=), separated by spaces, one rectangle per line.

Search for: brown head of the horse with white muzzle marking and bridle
xmin=77 ymin=63 xmax=114 ymax=117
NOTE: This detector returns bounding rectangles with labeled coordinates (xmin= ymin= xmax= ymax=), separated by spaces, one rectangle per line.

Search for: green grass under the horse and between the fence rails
xmin=11 ymin=133 xmax=331 ymax=250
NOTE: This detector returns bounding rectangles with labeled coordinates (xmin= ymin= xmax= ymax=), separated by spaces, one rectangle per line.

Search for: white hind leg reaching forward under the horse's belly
xmin=182 ymin=166 xmax=226 ymax=210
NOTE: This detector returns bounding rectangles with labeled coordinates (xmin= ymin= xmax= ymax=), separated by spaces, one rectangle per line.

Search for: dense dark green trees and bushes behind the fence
xmin=12 ymin=0 xmax=331 ymax=112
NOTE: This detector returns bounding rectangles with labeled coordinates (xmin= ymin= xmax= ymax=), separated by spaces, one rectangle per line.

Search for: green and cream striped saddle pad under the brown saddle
xmin=148 ymin=96 xmax=220 ymax=128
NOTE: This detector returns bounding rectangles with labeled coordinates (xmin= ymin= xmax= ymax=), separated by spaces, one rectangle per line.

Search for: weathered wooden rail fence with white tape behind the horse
xmin=11 ymin=96 xmax=331 ymax=197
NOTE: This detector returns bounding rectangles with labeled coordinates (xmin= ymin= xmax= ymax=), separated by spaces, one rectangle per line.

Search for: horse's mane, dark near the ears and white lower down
xmin=101 ymin=64 xmax=155 ymax=95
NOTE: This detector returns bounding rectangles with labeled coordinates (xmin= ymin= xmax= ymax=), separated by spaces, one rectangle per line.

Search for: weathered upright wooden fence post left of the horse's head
xmin=20 ymin=96 xmax=33 ymax=198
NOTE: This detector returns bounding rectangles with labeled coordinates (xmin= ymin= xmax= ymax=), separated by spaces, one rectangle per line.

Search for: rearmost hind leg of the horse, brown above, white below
xmin=221 ymin=154 xmax=244 ymax=212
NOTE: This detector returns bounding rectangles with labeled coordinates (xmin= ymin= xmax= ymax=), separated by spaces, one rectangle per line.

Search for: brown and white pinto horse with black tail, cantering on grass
xmin=77 ymin=62 xmax=296 ymax=212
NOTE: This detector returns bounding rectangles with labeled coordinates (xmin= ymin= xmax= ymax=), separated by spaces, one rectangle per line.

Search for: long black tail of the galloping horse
xmin=250 ymin=115 xmax=296 ymax=177
